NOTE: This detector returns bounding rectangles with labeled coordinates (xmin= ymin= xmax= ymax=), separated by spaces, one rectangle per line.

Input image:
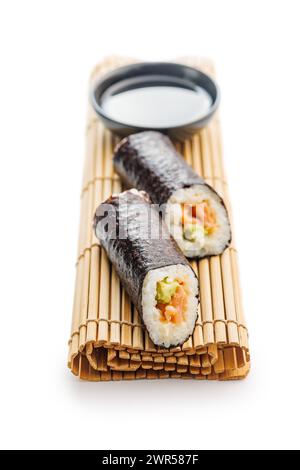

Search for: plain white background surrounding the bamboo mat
xmin=0 ymin=0 xmax=300 ymax=449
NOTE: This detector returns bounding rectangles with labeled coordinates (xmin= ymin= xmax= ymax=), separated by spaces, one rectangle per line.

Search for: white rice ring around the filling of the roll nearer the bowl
xmin=165 ymin=185 xmax=231 ymax=258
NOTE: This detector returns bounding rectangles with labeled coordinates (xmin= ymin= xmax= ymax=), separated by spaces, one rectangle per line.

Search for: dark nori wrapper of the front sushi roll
xmin=94 ymin=190 xmax=196 ymax=317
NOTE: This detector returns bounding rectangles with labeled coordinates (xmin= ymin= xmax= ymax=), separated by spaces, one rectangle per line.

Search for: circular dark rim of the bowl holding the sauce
xmin=90 ymin=61 xmax=220 ymax=131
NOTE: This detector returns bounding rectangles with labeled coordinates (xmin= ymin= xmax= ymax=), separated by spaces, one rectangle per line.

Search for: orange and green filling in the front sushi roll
xmin=156 ymin=278 xmax=187 ymax=324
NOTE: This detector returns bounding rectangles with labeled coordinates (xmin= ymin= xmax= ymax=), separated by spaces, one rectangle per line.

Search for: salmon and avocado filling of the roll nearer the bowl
xmin=181 ymin=200 xmax=218 ymax=241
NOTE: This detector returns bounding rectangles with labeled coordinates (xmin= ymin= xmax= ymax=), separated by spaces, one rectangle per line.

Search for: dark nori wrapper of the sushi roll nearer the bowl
xmin=114 ymin=131 xmax=216 ymax=205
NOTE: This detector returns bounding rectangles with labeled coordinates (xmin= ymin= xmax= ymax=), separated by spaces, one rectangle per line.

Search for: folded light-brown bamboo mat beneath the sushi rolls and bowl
xmin=68 ymin=57 xmax=250 ymax=381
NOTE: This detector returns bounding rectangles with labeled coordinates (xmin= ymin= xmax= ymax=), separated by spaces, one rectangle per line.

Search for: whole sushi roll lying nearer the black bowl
xmin=114 ymin=131 xmax=231 ymax=258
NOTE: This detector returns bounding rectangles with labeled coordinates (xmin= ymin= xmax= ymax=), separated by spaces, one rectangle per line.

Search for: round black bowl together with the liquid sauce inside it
xmin=91 ymin=62 xmax=219 ymax=138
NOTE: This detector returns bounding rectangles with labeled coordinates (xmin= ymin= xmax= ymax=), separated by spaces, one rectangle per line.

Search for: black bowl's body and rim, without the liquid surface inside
xmin=91 ymin=62 xmax=220 ymax=139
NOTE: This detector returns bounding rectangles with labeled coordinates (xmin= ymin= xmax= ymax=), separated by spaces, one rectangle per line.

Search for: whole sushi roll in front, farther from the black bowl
xmin=94 ymin=189 xmax=199 ymax=348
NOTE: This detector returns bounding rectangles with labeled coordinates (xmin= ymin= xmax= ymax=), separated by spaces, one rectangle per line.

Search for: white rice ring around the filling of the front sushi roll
xmin=142 ymin=264 xmax=198 ymax=348
